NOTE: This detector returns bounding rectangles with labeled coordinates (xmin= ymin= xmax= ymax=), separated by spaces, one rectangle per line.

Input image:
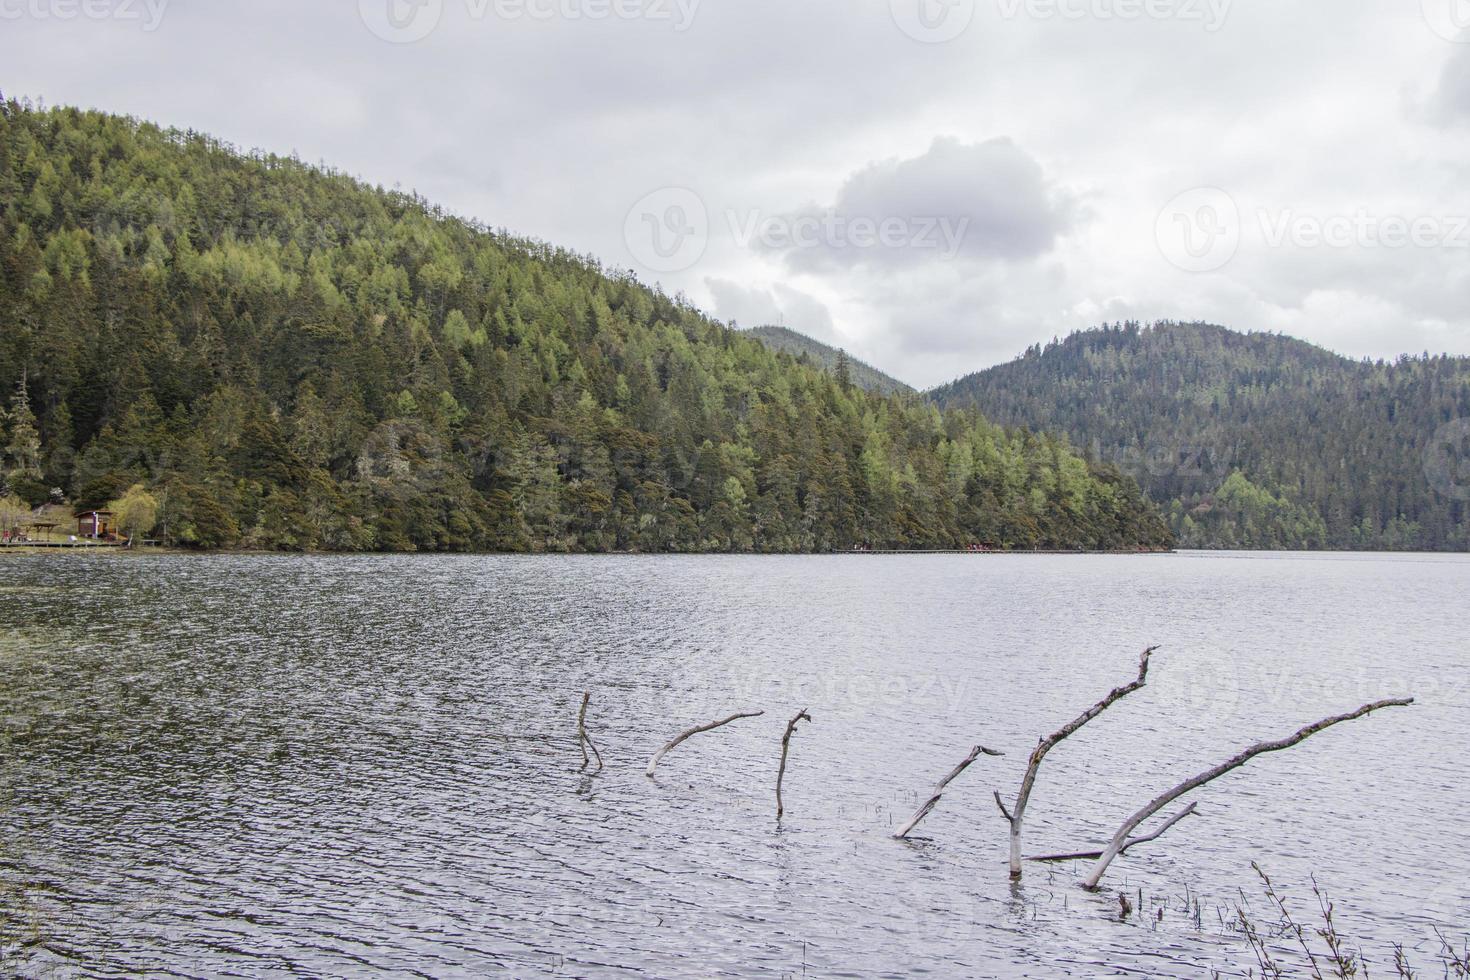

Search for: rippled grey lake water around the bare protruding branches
xmin=0 ymin=554 xmax=1470 ymax=977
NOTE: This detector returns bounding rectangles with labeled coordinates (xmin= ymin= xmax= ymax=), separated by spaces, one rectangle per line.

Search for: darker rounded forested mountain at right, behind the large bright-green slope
xmin=932 ymin=323 xmax=1470 ymax=550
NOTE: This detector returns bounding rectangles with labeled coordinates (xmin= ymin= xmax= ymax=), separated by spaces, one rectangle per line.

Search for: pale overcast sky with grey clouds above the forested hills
xmin=0 ymin=0 xmax=1470 ymax=386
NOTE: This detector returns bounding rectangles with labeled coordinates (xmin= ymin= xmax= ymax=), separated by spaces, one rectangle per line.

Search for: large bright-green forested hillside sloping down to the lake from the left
xmin=0 ymin=101 xmax=1170 ymax=551
